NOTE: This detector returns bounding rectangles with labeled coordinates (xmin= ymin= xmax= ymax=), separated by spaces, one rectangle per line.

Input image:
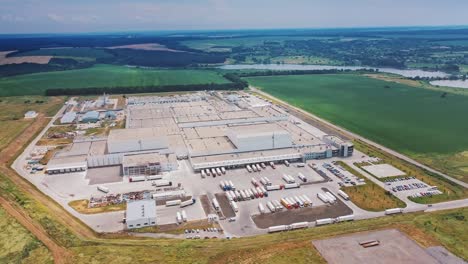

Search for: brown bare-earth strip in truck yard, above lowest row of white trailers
xmin=252 ymin=199 xmax=353 ymax=228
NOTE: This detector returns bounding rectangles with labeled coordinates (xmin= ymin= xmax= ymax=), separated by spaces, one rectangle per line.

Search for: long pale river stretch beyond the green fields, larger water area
xmin=220 ymin=64 xmax=449 ymax=78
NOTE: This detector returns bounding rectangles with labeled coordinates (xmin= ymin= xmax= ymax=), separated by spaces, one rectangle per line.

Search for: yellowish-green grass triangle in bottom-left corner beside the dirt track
xmin=0 ymin=207 xmax=53 ymax=263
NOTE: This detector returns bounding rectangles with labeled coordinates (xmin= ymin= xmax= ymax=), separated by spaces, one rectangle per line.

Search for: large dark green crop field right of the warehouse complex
xmin=246 ymin=74 xmax=468 ymax=182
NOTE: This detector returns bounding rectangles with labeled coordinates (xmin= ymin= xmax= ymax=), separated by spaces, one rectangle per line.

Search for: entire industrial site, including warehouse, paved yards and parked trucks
xmin=13 ymin=91 xmax=441 ymax=241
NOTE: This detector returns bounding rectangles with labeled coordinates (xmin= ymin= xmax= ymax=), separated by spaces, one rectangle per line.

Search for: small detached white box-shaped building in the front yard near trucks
xmin=125 ymin=199 xmax=156 ymax=229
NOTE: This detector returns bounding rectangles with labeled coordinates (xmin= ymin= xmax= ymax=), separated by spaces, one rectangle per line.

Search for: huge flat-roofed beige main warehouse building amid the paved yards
xmin=47 ymin=93 xmax=353 ymax=176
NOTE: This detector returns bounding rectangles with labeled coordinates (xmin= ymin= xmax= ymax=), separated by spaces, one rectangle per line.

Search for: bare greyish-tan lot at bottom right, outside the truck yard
xmin=312 ymin=229 xmax=439 ymax=264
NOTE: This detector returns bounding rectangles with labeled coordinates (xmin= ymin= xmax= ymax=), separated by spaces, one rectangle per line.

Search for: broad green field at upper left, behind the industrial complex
xmin=0 ymin=65 xmax=229 ymax=96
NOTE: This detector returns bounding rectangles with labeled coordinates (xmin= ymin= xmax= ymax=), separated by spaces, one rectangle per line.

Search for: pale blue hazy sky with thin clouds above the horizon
xmin=0 ymin=0 xmax=468 ymax=33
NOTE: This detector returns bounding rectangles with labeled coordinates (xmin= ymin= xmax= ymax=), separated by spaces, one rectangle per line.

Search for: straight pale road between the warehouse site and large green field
xmin=249 ymin=86 xmax=468 ymax=188
